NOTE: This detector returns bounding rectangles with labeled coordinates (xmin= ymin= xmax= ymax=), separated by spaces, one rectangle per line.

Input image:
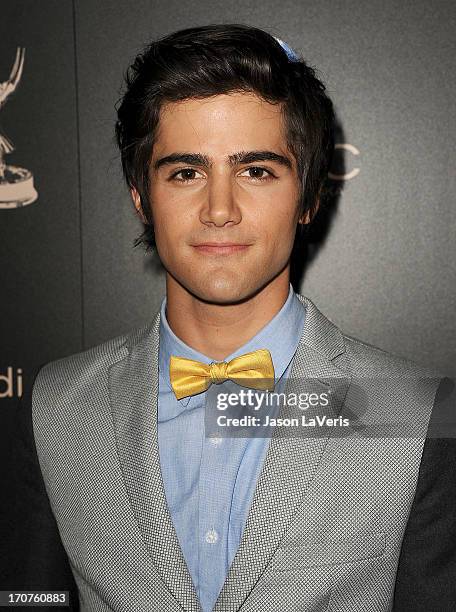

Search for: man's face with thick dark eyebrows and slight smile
xmin=141 ymin=93 xmax=299 ymax=304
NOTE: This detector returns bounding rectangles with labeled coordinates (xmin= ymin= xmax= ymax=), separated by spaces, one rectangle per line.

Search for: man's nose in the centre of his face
xmin=200 ymin=173 xmax=241 ymax=227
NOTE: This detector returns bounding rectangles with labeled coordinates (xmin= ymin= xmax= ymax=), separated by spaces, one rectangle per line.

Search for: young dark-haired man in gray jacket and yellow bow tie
xmin=3 ymin=25 xmax=456 ymax=612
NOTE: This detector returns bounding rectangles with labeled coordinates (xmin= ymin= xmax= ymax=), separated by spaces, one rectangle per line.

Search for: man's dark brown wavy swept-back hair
xmin=115 ymin=24 xmax=334 ymax=249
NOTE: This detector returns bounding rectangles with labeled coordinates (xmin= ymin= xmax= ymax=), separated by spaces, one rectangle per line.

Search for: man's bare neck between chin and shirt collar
xmin=166 ymin=267 xmax=290 ymax=361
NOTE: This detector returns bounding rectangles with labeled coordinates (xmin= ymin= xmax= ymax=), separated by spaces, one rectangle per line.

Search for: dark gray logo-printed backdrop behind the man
xmin=0 ymin=0 xmax=456 ymax=448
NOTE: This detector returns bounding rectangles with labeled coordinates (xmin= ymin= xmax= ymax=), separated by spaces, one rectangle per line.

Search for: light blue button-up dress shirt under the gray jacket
xmin=158 ymin=283 xmax=306 ymax=612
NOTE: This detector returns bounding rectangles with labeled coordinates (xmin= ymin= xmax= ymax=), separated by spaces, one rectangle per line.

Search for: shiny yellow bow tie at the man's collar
xmin=169 ymin=349 xmax=274 ymax=399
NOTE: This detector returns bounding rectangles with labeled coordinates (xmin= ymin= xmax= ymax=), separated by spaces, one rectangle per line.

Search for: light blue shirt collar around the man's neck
xmin=159 ymin=283 xmax=306 ymax=406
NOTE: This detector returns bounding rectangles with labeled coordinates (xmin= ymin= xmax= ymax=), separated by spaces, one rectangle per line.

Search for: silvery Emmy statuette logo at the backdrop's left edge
xmin=0 ymin=47 xmax=38 ymax=208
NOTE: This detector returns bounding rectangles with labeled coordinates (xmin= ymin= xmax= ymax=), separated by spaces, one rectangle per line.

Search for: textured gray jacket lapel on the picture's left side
xmin=109 ymin=313 xmax=200 ymax=612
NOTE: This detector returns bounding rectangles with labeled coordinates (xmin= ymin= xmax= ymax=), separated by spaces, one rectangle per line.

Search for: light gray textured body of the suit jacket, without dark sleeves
xmin=26 ymin=296 xmax=439 ymax=612
